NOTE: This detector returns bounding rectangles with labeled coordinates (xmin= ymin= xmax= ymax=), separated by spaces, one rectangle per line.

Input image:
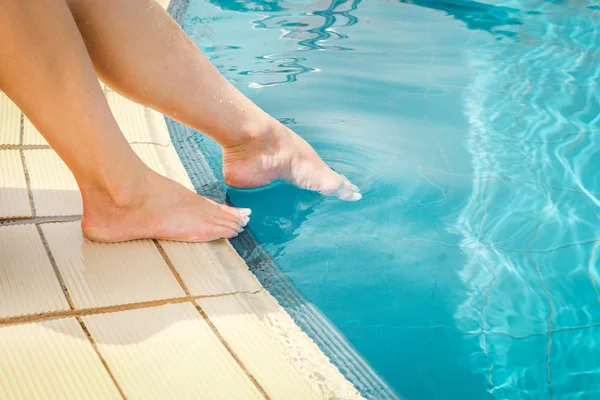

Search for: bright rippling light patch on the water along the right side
xmin=455 ymin=2 xmax=600 ymax=399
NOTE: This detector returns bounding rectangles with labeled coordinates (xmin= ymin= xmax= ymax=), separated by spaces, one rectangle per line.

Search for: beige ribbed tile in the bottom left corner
xmin=0 ymin=318 xmax=121 ymax=400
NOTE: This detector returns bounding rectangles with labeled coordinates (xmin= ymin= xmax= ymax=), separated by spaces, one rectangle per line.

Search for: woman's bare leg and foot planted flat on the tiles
xmin=0 ymin=0 xmax=248 ymax=241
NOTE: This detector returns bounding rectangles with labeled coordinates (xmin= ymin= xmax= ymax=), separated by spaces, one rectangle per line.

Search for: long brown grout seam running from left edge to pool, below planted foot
xmin=0 ymin=289 xmax=262 ymax=327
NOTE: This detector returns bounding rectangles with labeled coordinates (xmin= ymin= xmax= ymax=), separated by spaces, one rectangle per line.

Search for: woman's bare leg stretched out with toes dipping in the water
xmin=67 ymin=0 xmax=360 ymax=200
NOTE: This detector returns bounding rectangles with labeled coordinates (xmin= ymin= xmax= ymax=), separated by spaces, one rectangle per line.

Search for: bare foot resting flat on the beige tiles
xmin=81 ymin=170 xmax=250 ymax=242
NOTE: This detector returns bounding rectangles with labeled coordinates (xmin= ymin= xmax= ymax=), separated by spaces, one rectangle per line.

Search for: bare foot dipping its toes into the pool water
xmin=223 ymin=121 xmax=362 ymax=201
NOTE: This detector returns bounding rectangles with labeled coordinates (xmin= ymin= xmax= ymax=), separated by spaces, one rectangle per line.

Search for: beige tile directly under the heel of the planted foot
xmin=42 ymin=222 xmax=185 ymax=308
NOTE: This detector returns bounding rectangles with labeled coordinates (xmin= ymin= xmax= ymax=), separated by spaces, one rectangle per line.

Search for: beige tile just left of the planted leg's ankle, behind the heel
xmin=25 ymin=149 xmax=82 ymax=216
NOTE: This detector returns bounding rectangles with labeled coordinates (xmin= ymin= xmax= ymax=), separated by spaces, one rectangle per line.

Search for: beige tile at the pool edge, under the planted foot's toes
xmin=161 ymin=240 xmax=261 ymax=296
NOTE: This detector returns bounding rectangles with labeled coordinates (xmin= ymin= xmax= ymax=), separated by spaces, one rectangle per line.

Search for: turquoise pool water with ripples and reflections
xmin=184 ymin=0 xmax=600 ymax=399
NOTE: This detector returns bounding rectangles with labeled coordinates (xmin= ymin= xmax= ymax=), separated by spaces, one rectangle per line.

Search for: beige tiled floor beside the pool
xmin=0 ymin=9 xmax=360 ymax=394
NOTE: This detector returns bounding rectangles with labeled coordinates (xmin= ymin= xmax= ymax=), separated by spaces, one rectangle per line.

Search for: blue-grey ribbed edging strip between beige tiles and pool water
xmin=166 ymin=0 xmax=398 ymax=399
